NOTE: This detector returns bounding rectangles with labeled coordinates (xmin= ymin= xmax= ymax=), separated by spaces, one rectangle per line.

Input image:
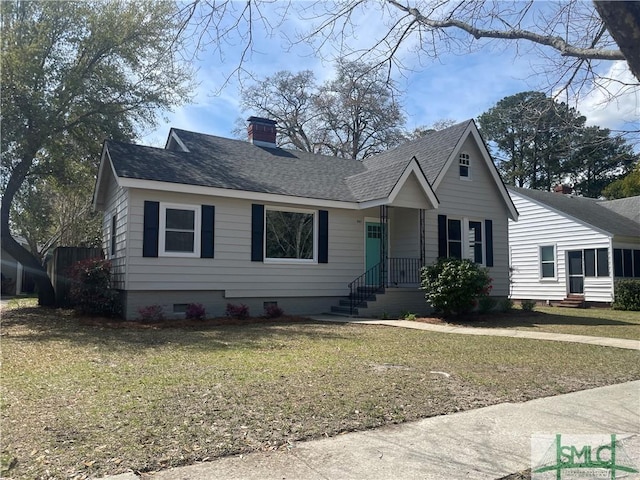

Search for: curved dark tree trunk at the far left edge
xmin=0 ymin=155 xmax=56 ymax=307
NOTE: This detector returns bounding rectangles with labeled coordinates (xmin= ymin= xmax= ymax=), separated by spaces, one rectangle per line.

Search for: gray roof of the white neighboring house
xmin=508 ymin=187 xmax=640 ymax=237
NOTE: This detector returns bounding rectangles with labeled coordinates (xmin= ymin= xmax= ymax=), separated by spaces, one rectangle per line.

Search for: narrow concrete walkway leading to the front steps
xmin=309 ymin=315 xmax=640 ymax=350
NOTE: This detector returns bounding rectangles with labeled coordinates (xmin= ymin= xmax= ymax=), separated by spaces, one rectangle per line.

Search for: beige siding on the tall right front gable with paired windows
xmin=426 ymin=137 xmax=509 ymax=297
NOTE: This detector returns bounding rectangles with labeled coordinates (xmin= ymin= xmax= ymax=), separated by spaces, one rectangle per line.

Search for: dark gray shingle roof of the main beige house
xmin=106 ymin=121 xmax=470 ymax=202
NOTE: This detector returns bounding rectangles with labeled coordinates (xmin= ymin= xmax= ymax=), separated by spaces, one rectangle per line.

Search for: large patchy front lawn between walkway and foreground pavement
xmin=0 ymin=307 xmax=640 ymax=479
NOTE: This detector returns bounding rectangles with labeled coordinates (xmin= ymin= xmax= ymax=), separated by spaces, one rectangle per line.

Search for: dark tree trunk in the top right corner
xmin=594 ymin=0 xmax=640 ymax=81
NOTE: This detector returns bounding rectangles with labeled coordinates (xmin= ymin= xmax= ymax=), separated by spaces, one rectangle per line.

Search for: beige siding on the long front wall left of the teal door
xmin=128 ymin=190 xmax=364 ymax=299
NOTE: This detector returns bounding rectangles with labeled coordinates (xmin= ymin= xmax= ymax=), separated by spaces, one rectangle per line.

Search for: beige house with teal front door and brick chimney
xmin=94 ymin=117 xmax=517 ymax=319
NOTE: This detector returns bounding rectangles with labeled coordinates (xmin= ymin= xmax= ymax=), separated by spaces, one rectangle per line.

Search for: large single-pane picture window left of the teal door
xmin=265 ymin=207 xmax=316 ymax=261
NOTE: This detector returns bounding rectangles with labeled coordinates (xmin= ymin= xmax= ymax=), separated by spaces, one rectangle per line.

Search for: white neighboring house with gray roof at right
xmin=509 ymin=186 xmax=640 ymax=304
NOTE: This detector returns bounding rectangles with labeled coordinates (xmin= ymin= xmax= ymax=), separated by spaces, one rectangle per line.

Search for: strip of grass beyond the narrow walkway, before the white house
xmin=462 ymin=307 xmax=640 ymax=340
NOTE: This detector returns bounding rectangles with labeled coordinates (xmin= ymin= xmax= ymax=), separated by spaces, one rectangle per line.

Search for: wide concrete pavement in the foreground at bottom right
xmin=108 ymin=381 xmax=640 ymax=480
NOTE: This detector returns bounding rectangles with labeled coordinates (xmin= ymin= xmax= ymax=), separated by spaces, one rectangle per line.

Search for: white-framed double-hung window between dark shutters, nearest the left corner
xmin=160 ymin=204 xmax=200 ymax=257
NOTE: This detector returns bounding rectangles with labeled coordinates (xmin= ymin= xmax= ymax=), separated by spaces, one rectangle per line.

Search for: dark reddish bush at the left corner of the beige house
xmin=69 ymin=258 xmax=122 ymax=317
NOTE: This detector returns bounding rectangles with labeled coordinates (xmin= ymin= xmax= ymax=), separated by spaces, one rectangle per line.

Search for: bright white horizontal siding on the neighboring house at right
xmin=509 ymin=192 xmax=613 ymax=302
